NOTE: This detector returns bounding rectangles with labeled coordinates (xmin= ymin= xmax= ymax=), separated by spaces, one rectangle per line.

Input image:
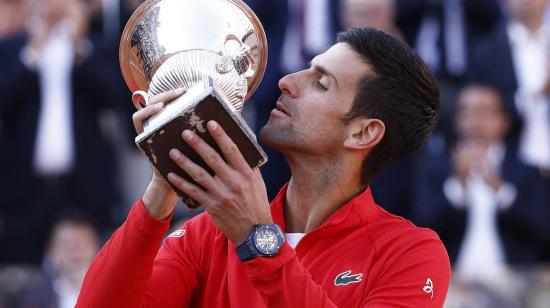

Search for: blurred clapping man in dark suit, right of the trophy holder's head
xmin=415 ymin=84 xmax=549 ymax=284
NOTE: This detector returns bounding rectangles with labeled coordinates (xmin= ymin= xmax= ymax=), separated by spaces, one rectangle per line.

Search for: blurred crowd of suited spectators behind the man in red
xmin=0 ymin=0 xmax=550 ymax=307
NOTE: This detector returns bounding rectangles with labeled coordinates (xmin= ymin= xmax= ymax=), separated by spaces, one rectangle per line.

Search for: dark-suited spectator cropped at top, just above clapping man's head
xmin=396 ymin=0 xmax=502 ymax=141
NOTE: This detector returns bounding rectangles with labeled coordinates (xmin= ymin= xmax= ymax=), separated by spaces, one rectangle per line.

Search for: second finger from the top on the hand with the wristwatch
xmin=182 ymin=130 xmax=231 ymax=179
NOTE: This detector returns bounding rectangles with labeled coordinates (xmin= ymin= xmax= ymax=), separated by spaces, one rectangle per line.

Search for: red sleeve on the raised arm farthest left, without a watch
xmin=76 ymin=200 xmax=201 ymax=307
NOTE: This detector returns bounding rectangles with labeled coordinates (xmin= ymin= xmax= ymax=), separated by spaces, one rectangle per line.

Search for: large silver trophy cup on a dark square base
xmin=119 ymin=0 xmax=267 ymax=209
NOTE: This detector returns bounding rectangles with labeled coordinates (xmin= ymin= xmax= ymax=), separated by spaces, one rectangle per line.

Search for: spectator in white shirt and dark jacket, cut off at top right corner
xmin=471 ymin=0 xmax=550 ymax=172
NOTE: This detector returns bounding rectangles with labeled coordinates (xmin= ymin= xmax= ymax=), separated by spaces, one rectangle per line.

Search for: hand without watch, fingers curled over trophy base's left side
xmin=132 ymin=89 xmax=184 ymax=220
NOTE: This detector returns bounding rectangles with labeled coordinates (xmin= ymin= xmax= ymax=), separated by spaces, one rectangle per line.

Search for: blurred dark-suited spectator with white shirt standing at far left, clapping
xmin=0 ymin=0 xmax=121 ymax=264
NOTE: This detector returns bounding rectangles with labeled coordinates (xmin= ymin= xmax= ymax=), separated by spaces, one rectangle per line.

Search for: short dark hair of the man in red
xmin=337 ymin=28 xmax=439 ymax=185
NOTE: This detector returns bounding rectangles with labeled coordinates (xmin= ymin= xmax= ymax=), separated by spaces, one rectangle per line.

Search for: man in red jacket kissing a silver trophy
xmin=77 ymin=28 xmax=450 ymax=307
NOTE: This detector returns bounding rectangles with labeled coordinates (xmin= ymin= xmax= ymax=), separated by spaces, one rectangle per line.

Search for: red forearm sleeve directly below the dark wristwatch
xmin=245 ymin=242 xmax=336 ymax=308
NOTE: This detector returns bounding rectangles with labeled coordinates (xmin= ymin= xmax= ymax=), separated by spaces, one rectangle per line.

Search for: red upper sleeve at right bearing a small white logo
xmin=364 ymin=229 xmax=451 ymax=308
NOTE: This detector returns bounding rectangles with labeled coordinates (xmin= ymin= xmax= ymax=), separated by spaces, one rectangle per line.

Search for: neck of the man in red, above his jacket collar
xmin=284 ymin=153 xmax=364 ymax=233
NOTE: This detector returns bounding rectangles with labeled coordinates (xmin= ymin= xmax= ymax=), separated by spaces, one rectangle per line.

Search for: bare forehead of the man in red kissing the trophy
xmin=311 ymin=43 xmax=373 ymax=89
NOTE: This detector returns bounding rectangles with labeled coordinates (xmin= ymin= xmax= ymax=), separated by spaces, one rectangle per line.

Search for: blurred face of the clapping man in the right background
xmin=456 ymin=88 xmax=508 ymax=144
